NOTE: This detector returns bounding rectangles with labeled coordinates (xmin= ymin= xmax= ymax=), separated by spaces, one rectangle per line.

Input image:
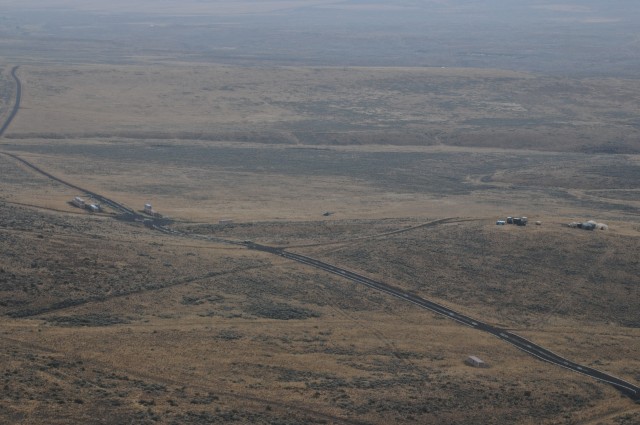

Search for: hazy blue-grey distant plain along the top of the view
xmin=0 ymin=0 xmax=640 ymax=78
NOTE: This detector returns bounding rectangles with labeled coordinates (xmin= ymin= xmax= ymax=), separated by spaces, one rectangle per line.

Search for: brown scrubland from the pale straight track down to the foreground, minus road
xmin=0 ymin=133 xmax=640 ymax=424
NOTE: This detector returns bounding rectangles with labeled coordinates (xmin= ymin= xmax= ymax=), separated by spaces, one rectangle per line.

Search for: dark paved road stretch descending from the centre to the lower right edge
xmin=246 ymin=243 xmax=640 ymax=402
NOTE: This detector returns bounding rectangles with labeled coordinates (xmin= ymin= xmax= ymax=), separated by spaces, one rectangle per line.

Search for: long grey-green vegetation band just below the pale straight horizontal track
xmin=0 ymin=143 xmax=548 ymax=195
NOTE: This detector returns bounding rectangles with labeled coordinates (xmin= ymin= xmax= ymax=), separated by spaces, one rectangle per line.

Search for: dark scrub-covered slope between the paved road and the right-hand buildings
xmin=297 ymin=221 xmax=640 ymax=328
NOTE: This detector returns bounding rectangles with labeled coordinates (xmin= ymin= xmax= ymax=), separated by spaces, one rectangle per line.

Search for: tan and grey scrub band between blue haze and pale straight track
xmin=7 ymin=64 xmax=640 ymax=153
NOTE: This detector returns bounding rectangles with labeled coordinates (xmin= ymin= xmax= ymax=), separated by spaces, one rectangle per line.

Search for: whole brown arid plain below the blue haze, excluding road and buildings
xmin=0 ymin=1 xmax=640 ymax=425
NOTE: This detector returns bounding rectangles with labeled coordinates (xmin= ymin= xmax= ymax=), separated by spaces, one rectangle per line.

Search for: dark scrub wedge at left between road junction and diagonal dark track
xmin=0 ymin=203 xmax=265 ymax=317
